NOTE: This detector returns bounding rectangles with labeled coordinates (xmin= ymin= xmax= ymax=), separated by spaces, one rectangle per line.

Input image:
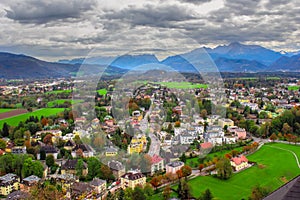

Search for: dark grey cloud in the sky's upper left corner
xmin=5 ymin=0 xmax=96 ymax=24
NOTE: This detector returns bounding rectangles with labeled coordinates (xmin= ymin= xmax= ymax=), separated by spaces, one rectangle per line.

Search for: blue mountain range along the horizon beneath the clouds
xmin=0 ymin=42 xmax=300 ymax=79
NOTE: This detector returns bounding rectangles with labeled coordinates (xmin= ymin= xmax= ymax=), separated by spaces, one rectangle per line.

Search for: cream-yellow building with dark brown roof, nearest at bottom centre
xmin=121 ymin=172 xmax=146 ymax=189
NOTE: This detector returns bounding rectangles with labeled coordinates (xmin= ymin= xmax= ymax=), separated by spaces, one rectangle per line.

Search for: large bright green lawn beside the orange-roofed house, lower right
xmin=185 ymin=144 xmax=300 ymax=200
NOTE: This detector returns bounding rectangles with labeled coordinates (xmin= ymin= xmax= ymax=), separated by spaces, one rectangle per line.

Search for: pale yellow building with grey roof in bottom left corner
xmin=0 ymin=174 xmax=20 ymax=196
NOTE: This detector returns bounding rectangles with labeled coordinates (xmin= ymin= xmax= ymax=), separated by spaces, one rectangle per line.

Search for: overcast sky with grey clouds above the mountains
xmin=0 ymin=0 xmax=300 ymax=60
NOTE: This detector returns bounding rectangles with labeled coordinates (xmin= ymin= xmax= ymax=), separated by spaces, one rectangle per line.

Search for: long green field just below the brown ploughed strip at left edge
xmin=0 ymin=108 xmax=64 ymax=128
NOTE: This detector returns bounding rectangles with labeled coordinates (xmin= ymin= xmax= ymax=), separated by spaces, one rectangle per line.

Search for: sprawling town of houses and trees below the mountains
xmin=0 ymin=77 xmax=300 ymax=199
